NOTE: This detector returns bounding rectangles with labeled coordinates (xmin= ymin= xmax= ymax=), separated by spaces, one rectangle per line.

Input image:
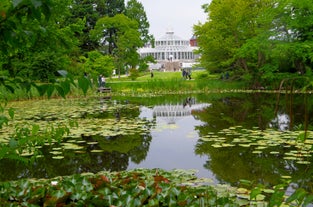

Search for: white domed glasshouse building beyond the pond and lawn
xmin=139 ymin=30 xmax=198 ymax=71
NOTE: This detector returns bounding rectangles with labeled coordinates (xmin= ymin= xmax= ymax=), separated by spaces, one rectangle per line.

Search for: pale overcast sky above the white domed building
xmin=138 ymin=0 xmax=211 ymax=39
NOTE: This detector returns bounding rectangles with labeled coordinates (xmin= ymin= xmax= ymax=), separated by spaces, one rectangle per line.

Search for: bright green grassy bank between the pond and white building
xmin=107 ymin=71 xmax=245 ymax=93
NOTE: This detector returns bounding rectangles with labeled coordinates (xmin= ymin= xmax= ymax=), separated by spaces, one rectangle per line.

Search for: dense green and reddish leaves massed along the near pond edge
xmin=0 ymin=169 xmax=239 ymax=207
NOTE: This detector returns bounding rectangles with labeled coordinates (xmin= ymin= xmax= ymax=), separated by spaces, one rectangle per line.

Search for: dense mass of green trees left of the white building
xmin=0 ymin=0 xmax=152 ymax=82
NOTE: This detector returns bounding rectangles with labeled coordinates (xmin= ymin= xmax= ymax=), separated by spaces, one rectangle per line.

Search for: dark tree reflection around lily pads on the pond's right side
xmin=194 ymin=94 xmax=313 ymax=189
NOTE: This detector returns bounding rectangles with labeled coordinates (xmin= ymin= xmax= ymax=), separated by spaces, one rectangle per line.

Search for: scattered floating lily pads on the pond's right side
xmin=200 ymin=126 xmax=313 ymax=164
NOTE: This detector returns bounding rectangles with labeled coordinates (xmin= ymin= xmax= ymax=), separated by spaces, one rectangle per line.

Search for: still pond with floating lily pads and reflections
xmin=0 ymin=93 xmax=313 ymax=191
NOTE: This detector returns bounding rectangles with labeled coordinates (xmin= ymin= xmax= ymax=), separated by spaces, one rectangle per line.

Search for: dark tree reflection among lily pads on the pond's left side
xmin=0 ymin=100 xmax=154 ymax=181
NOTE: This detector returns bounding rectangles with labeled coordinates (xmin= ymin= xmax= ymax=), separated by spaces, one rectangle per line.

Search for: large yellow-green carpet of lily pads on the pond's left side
xmin=0 ymin=99 xmax=153 ymax=162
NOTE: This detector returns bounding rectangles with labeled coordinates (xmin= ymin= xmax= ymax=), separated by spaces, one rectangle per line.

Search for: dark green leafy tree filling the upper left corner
xmin=0 ymin=0 xmax=83 ymax=81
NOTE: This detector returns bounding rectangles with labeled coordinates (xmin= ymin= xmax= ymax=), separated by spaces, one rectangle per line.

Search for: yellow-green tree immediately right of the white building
xmin=194 ymin=0 xmax=270 ymax=72
